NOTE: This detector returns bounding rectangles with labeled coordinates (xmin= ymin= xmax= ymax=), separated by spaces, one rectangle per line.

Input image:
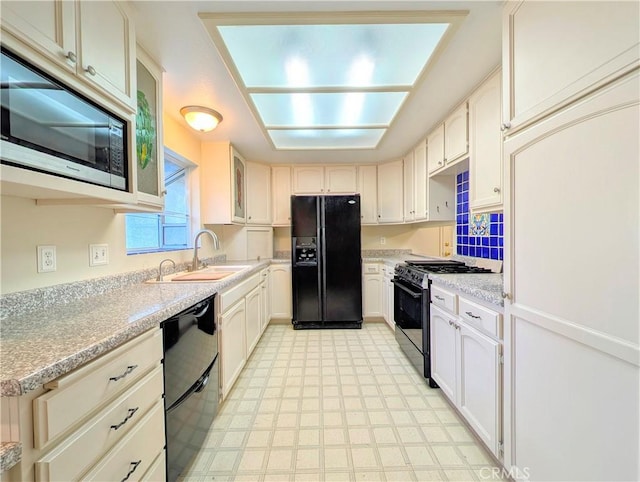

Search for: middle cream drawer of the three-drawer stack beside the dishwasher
xmin=36 ymin=365 xmax=163 ymax=482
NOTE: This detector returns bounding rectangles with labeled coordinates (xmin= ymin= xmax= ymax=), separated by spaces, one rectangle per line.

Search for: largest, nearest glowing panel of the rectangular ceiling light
xmin=218 ymin=23 xmax=449 ymax=89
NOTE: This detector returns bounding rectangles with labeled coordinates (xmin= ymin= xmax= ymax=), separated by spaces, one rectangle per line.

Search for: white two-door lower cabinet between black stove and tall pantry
xmin=430 ymin=290 xmax=502 ymax=458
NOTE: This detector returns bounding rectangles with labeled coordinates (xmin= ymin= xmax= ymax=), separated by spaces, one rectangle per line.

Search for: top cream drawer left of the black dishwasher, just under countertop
xmin=33 ymin=329 xmax=162 ymax=448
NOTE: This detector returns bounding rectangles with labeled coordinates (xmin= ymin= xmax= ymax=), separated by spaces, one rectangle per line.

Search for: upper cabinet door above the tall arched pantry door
xmin=502 ymin=1 xmax=640 ymax=133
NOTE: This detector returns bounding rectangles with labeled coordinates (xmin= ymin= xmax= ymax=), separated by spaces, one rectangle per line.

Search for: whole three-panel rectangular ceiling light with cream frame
xmin=199 ymin=10 xmax=468 ymax=149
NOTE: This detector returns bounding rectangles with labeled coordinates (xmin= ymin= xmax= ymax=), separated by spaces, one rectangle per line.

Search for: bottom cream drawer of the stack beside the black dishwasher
xmin=82 ymin=401 xmax=164 ymax=482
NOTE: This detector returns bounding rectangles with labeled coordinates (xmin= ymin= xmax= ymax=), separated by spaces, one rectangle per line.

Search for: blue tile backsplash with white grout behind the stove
xmin=456 ymin=171 xmax=504 ymax=260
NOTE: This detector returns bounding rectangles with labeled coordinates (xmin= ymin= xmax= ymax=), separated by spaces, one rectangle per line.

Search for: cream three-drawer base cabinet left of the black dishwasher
xmin=2 ymin=329 xmax=165 ymax=482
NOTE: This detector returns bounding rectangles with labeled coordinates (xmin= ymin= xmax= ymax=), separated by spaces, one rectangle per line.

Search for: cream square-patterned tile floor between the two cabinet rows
xmin=178 ymin=323 xmax=502 ymax=482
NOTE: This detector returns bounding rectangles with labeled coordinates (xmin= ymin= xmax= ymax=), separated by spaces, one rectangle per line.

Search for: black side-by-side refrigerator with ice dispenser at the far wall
xmin=291 ymin=194 xmax=362 ymax=329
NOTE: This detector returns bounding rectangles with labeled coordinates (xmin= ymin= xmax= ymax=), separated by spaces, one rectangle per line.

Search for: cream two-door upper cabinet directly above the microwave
xmin=2 ymin=0 xmax=136 ymax=111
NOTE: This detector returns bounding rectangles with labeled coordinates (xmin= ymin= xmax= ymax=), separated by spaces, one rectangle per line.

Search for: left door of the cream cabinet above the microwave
xmin=2 ymin=0 xmax=78 ymax=73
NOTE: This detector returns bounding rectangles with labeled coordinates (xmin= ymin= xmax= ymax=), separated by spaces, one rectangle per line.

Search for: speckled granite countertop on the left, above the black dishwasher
xmin=0 ymin=260 xmax=271 ymax=396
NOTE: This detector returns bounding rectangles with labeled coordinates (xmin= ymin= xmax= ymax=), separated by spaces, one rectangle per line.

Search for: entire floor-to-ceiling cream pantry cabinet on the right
xmin=503 ymin=1 xmax=640 ymax=480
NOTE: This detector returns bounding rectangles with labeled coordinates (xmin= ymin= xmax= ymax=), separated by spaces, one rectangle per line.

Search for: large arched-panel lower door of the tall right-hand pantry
xmin=503 ymin=69 xmax=640 ymax=480
